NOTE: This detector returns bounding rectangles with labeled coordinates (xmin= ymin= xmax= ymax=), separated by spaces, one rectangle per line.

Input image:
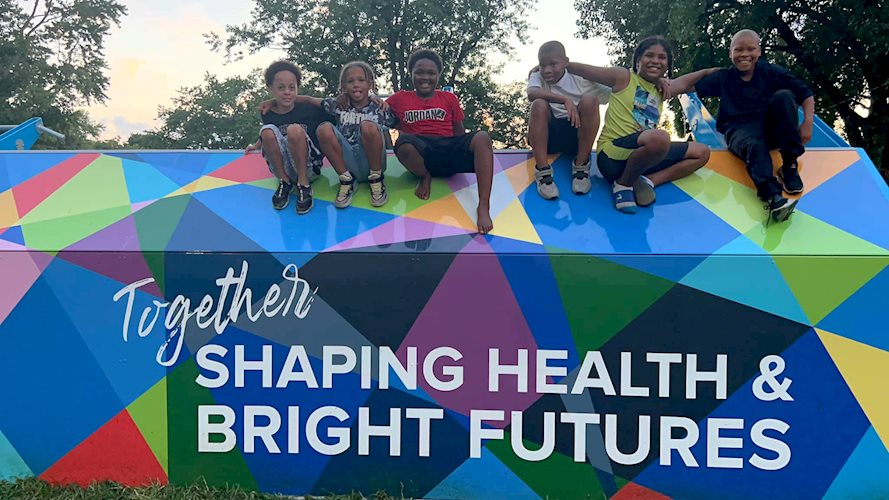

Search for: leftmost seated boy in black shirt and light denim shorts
xmin=247 ymin=61 xmax=334 ymax=215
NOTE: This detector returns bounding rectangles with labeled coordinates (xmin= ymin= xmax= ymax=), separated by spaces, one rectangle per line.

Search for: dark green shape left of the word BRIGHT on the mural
xmin=166 ymin=359 xmax=258 ymax=490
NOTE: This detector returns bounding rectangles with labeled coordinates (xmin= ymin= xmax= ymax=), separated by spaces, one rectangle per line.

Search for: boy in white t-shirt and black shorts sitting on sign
xmin=528 ymin=41 xmax=611 ymax=200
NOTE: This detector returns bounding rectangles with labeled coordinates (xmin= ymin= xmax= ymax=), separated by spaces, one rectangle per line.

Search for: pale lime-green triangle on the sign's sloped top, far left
xmin=22 ymin=155 xmax=130 ymax=226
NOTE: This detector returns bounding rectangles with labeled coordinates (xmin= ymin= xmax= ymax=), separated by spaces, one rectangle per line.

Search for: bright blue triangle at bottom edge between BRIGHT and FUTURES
xmin=424 ymin=448 xmax=540 ymax=499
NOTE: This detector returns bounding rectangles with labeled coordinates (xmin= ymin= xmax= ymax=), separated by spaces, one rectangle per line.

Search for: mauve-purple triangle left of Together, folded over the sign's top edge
xmin=59 ymin=216 xmax=163 ymax=297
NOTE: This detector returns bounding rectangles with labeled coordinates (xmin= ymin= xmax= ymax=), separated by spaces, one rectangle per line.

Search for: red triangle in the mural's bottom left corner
xmin=40 ymin=410 xmax=168 ymax=487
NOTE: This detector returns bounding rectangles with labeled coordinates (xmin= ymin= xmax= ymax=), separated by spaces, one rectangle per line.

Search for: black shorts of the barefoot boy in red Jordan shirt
xmin=395 ymin=131 xmax=478 ymax=177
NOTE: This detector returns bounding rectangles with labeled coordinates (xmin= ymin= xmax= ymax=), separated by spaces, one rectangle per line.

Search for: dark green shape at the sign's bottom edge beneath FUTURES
xmin=485 ymin=431 xmax=607 ymax=498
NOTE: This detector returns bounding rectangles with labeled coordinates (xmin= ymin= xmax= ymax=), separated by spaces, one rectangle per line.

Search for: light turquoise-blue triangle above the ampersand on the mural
xmin=680 ymin=236 xmax=809 ymax=324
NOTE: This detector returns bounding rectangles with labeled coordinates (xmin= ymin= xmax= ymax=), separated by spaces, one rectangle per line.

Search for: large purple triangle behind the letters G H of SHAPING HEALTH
xmin=398 ymin=238 xmax=540 ymax=427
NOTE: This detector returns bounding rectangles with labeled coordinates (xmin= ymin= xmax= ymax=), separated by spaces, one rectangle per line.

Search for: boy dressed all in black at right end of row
xmin=677 ymin=30 xmax=815 ymax=222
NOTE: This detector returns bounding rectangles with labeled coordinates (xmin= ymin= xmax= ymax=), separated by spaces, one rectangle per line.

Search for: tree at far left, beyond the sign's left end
xmin=0 ymin=0 xmax=126 ymax=148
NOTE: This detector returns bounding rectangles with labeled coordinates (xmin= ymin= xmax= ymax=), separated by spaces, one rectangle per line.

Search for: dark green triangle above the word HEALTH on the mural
xmin=547 ymin=247 xmax=674 ymax=352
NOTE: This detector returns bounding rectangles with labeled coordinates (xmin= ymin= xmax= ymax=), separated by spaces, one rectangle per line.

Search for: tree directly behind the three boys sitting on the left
xmin=208 ymin=0 xmax=535 ymax=144
